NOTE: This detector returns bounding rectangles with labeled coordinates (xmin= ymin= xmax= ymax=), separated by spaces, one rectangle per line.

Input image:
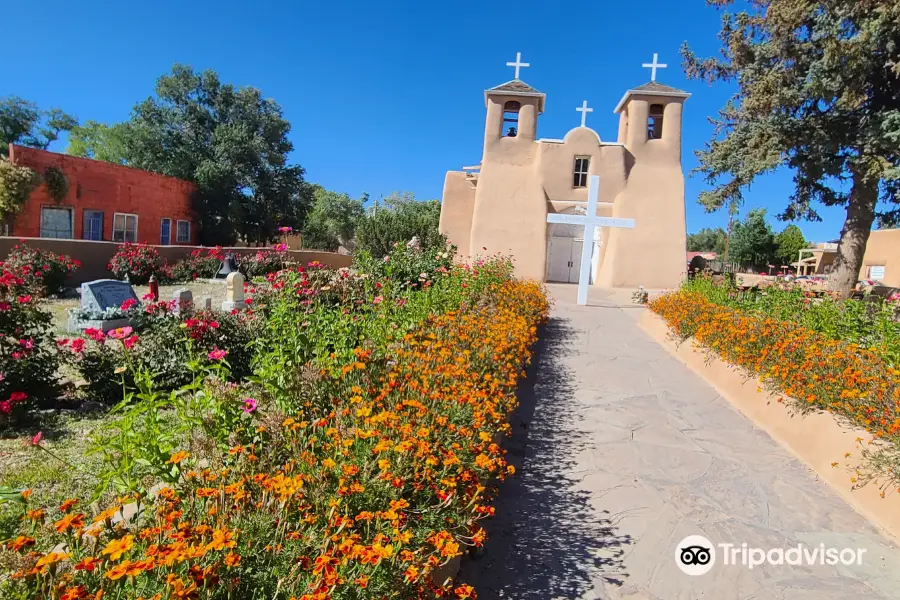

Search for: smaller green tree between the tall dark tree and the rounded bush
xmin=303 ymin=185 xmax=366 ymax=251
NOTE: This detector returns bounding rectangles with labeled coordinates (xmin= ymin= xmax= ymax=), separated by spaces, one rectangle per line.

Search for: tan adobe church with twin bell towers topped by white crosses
xmin=440 ymin=55 xmax=690 ymax=289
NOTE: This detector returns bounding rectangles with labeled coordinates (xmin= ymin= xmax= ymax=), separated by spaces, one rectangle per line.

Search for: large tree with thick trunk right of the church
xmin=682 ymin=0 xmax=900 ymax=295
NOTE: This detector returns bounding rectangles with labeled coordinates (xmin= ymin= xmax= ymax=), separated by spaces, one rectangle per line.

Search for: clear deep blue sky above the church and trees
xmin=0 ymin=0 xmax=844 ymax=241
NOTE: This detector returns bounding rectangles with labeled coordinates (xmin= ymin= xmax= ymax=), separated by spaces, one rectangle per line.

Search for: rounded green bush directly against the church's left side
xmin=356 ymin=192 xmax=447 ymax=257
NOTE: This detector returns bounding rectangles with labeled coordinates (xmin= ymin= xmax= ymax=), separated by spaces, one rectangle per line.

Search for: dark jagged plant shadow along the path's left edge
xmin=459 ymin=318 xmax=631 ymax=600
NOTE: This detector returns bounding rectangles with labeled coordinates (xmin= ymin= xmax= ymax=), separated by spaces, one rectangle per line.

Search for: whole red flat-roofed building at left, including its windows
xmin=2 ymin=144 xmax=198 ymax=246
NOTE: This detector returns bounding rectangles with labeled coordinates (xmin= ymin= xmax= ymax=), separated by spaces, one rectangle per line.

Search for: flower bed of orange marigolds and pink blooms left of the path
xmin=0 ymin=241 xmax=548 ymax=600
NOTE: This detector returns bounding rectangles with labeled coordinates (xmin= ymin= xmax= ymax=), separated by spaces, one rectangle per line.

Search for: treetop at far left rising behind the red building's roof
xmin=0 ymin=96 xmax=78 ymax=156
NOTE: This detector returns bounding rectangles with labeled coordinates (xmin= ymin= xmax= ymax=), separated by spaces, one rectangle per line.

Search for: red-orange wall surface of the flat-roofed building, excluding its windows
xmin=9 ymin=144 xmax=198 ymax=245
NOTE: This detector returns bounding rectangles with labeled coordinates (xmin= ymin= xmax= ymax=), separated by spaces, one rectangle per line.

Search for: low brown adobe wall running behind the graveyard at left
xmin=0 ymin=237 xmax=352 ymax=286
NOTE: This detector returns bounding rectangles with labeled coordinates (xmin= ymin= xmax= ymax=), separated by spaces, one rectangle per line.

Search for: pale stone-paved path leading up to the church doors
xmin=461 ymin=286 xmax=900 ymax=600
